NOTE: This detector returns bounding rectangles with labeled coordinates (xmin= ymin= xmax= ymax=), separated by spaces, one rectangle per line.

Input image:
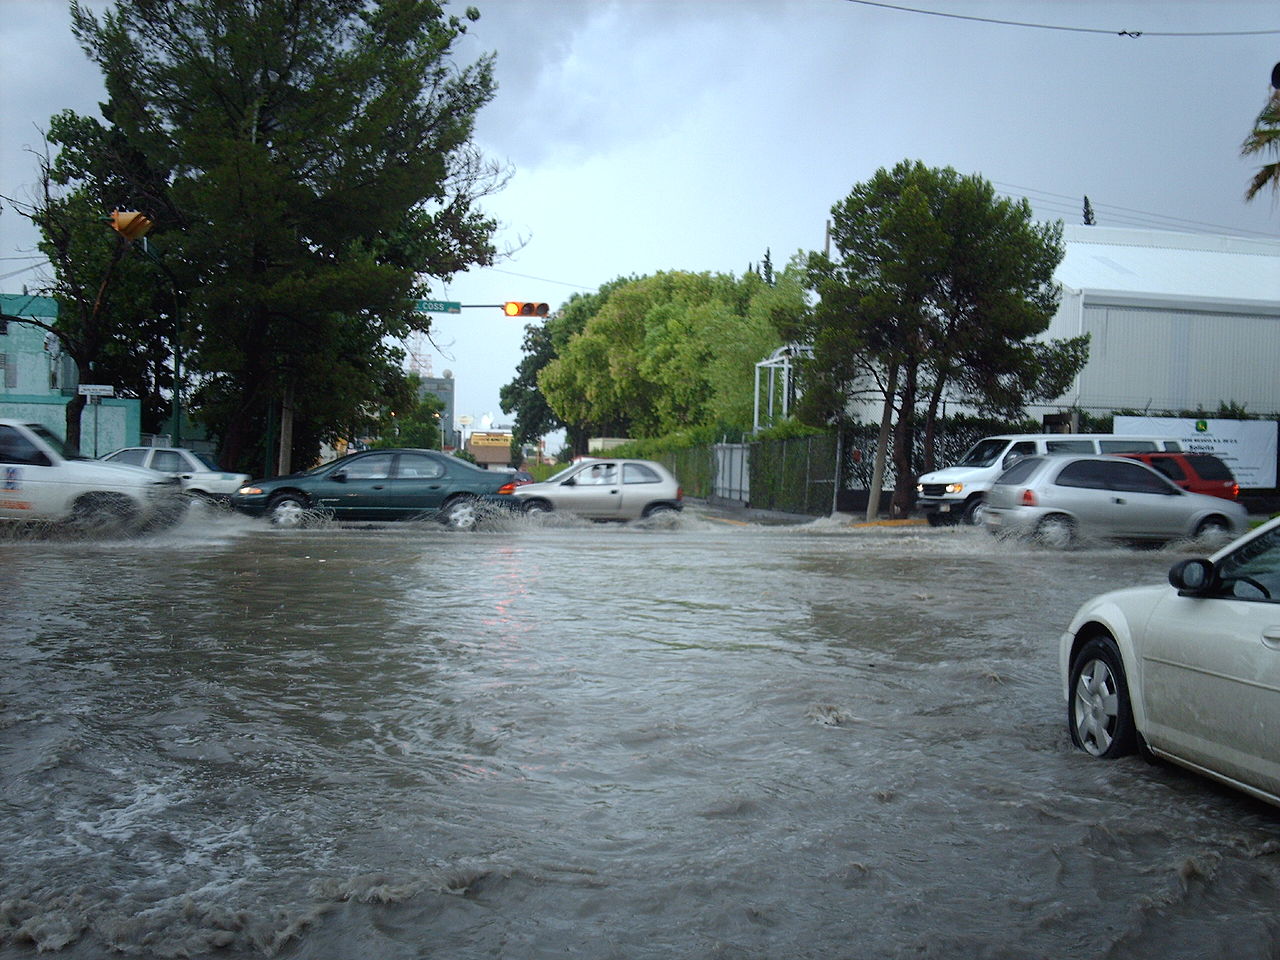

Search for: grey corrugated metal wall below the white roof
xmin=1078 ymin=302 xmax=1280 ymax=413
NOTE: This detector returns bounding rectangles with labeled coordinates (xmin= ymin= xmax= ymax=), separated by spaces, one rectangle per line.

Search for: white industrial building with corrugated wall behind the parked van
xmin=1029 ymin=225 xmax=1280 ymax=416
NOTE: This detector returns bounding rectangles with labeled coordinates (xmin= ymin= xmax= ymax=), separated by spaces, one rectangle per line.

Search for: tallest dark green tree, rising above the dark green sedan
xmin=53 ymin=0 xmax=506 ymax=468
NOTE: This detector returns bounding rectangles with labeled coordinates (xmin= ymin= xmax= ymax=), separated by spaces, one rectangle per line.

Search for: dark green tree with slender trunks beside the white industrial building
xmin=788 ymin=161 xmax=1088 ymax=512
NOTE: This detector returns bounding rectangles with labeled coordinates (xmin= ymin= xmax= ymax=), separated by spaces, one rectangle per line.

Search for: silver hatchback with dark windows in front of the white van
xmin=983 ymin=456 xmax=1248 ymax=545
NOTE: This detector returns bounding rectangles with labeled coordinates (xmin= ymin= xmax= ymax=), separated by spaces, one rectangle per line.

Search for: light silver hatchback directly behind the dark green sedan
xmin=512 ymin=460 xmax=685 ymax=520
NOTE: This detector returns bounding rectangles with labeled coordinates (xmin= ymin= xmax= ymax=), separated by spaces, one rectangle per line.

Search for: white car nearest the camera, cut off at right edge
xmin=1059 ymin=517 xmax=1280 ymax=805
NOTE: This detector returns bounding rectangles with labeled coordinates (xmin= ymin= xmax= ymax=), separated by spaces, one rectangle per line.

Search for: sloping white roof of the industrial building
xmin=1055 ymin=224 xmax=1280 ymax=312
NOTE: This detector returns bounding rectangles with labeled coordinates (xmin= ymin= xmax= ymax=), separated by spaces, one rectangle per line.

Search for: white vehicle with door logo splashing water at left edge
xmin=0 ymin=420 xmax=188 ymax=530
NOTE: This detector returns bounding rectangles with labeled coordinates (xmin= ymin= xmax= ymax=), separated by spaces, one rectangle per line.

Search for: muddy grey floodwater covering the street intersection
xmin=0 ymin=509 xmax=1280 ymax=960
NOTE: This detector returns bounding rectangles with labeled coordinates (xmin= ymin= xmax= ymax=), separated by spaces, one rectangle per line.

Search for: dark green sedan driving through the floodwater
xmin=232 ymin=449 xmax=511 ymax=530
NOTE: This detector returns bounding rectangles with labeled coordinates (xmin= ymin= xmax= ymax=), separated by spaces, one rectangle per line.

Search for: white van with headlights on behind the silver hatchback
xmin=915 ymin=434 xmax=1181 ymax=526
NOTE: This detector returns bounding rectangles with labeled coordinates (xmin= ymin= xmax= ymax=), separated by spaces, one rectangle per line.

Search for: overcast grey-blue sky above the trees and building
xmin=0 ymin=0 xmax=1280 ymax=429
